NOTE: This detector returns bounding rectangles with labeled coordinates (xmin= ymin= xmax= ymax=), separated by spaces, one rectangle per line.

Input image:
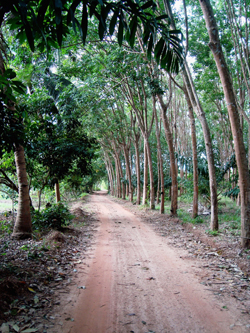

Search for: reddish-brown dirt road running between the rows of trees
xmin=51 ymin=195 xmax=249 ymax=333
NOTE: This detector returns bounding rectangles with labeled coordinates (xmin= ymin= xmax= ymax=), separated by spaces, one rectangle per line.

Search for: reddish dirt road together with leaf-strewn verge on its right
xmin=48 ymin=195 xmax=250 ymax=333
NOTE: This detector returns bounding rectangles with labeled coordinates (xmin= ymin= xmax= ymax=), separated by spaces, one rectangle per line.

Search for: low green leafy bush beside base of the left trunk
xmin=32 ymin=203 xmax=74 ymax=230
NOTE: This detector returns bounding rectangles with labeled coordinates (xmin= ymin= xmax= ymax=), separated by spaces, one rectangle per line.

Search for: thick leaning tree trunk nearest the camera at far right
xmin=199 ymin=0 xmax=250 ymax=248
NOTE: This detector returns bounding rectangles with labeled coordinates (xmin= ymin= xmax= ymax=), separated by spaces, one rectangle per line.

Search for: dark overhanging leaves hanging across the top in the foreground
xmin=0 ymin=0 xmax=182 ymax=72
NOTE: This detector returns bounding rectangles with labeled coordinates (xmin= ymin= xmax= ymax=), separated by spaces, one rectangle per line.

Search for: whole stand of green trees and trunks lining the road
xmin=0 ymin=0 xmax=250 ymax=248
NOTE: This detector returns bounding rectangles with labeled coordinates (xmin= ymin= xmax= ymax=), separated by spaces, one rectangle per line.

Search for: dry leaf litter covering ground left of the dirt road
xmin=0 ymin=198 xmax=96 ymax=333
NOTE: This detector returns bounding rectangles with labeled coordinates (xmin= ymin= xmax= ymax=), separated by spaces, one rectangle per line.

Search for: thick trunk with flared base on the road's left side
xmin=12 ymin=145 xmax=32 ymax=239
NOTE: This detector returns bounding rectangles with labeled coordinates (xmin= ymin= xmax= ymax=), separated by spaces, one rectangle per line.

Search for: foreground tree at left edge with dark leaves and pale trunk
xmin=0 ymin=50 xmax=31 ymax=239
